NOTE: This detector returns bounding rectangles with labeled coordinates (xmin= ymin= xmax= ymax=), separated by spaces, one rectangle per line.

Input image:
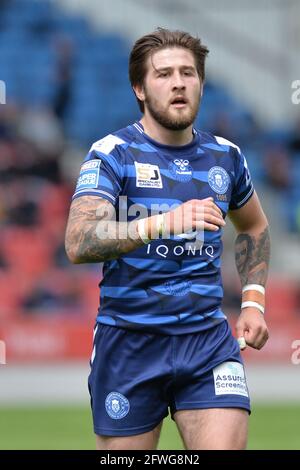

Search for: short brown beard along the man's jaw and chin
xmin=144 ymin=90 xmax=201 ymax=131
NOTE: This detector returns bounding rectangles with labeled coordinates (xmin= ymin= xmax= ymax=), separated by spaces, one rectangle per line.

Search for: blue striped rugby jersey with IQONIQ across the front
xmin=73 ymin=122 xmax=254 ymax=334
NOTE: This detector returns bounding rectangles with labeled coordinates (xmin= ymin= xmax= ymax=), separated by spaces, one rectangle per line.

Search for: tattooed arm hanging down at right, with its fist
xmin=229 ymin=193 xmax=270 ymax=349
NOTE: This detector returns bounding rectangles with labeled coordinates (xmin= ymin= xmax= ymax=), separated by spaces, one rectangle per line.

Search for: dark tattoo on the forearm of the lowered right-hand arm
xmin=235 ymin=227 xmax=270 ymax=286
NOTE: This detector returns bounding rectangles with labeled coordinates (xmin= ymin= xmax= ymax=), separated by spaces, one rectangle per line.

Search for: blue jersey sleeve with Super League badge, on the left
xmin=73 ymin=136 xmax=123 ymax=205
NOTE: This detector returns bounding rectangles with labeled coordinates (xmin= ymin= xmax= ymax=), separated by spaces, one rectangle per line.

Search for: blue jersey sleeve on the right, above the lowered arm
xmin=229 ymin=149 xmax=254 ymax=210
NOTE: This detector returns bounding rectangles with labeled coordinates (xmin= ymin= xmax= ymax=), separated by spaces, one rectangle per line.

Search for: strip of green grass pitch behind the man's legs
xmin=0 ymin=403 xmax=300 ymax=450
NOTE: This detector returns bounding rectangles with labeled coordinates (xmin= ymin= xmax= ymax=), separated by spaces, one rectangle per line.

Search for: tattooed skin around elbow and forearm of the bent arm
xmin=65 ymin=196 xmax=143 ymax=263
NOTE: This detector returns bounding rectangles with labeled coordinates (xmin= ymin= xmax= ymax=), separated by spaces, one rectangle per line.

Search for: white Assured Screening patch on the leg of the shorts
xmin=213 ymin=361 xmax=248 ymax=397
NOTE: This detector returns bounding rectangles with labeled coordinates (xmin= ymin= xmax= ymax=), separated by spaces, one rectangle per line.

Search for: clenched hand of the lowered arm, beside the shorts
xmin=236 ymin=307 xmax=269 ymax=349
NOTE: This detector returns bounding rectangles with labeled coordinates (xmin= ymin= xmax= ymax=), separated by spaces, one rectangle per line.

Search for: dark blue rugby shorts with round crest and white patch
xmin=88 ymin=320 xmax=250 ymax=436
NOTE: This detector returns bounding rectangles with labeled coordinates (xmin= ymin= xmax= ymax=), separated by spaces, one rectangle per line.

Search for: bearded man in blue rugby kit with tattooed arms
xmin=66 ymin=28 xmax=270 ymax=450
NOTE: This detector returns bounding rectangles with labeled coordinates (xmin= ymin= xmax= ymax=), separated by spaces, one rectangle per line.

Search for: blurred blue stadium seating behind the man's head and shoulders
xmin=0 ymin=0 xmax=300 ymax=231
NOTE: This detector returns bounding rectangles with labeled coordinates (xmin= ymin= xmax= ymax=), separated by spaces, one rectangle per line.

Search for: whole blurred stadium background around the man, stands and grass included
xmin=0 ymin=0 xmax=300 ymax=449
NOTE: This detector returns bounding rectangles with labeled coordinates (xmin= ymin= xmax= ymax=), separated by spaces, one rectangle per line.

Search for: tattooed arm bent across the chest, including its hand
xmin=65 ymin=196 xmax=224 ymax=263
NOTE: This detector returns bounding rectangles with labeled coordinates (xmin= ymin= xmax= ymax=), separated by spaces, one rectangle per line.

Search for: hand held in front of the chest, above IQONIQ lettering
xmin=165 ymin=197 xmax=226 ymax=235
